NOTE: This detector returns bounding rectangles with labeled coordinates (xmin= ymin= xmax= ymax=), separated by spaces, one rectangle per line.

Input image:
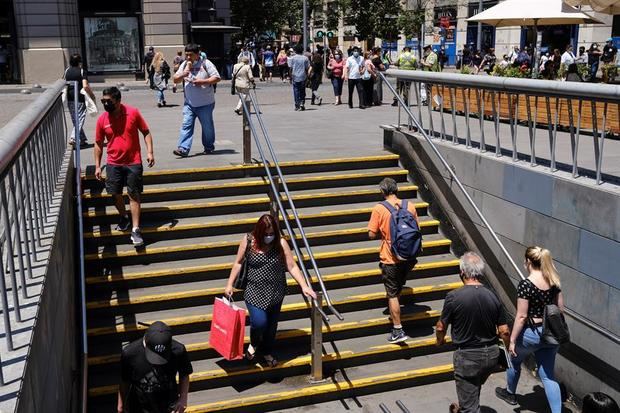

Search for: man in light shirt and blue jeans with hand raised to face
xmin=173 ymin=43 xmax=222 ymax=158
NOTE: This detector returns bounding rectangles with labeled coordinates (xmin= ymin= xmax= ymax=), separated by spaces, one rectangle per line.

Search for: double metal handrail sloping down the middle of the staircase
xmin=239 ymin=96 xmax=342 ymax=321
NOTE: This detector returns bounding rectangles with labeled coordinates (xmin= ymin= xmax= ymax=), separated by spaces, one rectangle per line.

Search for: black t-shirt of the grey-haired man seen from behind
xmin=441 ymin=285 xmax=507 ymax=348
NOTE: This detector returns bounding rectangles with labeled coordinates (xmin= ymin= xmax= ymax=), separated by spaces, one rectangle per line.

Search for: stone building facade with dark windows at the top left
xmin=0 ymin=0 xmax=235 ymax=83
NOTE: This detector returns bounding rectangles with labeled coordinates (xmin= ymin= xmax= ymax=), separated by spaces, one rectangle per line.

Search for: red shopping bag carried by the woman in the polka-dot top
xmin=209 ymin=298 xmax=245 ymax=360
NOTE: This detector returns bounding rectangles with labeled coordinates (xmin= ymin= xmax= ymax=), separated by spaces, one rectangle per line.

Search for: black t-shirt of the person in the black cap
xmin=121 ymin=339 xmax=193 ymax=413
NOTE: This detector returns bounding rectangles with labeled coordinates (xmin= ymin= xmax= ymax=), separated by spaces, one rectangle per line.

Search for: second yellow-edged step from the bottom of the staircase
xmin=88 ymin=337 xmax=452 ymax=397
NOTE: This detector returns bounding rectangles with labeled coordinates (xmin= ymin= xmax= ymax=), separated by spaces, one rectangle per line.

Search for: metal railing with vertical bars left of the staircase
xmin=0 ymin=80 xmax=66 ymax=384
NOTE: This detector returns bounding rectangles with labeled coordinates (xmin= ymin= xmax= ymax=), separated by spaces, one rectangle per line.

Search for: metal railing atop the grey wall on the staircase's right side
xmin=387 ymin=70 xmax=620 ymax=184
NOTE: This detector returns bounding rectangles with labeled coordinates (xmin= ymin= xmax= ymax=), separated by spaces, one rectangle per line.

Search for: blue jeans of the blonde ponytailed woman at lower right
xmin=506 ymin=326 xmax=562 ymax=413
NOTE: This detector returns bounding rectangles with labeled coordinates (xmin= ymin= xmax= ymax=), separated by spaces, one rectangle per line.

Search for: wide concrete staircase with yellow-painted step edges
xmin=83 ymin=155 xmax=460 ymax=412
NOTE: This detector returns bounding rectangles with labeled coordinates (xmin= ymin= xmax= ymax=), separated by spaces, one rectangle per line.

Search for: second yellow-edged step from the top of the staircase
xmin=82 ymin=170 xmax=408 ymax=207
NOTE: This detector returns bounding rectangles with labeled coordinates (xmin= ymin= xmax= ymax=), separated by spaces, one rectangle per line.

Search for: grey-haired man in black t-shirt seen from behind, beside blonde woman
xmin=435 ymin=252 xmax=510 ymax=413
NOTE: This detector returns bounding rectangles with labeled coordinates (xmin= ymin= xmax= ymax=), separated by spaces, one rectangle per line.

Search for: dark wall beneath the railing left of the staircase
xmin=15 ymin=160 xmax=80 ymax=413
